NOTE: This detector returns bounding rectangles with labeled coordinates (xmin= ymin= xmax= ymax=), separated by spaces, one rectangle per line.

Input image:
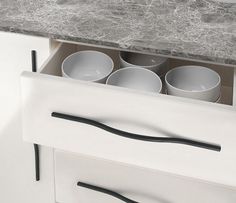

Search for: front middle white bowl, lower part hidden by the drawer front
xmin=106 ymin=67 xmax=162 ymax=93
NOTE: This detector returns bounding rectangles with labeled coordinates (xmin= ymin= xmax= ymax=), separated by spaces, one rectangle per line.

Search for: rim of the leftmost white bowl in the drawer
xmin=61 ymin=50 xmax=114 ymax=82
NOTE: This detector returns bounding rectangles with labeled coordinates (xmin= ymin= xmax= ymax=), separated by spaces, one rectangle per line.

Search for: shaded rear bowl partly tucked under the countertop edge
xmin=120 ymin=51 xmax=168 ymax=76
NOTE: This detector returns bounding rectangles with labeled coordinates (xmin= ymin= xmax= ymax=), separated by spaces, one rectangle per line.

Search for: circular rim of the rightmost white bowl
xmin=165 ymin=65 xmax=221 ymax=93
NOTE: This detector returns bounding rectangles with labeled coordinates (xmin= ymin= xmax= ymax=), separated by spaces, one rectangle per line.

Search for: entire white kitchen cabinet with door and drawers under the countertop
xmin=0 ymin=30 xmax=236 ymax=203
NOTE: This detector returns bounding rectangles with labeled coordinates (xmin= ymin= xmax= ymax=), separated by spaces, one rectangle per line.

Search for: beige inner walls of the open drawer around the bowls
xmin=40 ymin=43 xmax=234 ymax=105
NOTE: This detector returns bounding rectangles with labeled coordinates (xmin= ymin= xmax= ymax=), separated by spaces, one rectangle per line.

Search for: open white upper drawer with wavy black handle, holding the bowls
xmin=21 ymin=43 xmax=236 ymax=187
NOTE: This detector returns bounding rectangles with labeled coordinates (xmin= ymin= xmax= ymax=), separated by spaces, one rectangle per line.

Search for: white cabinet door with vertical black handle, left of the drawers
xmin=0 ymin=32 xmax=54 ymax=203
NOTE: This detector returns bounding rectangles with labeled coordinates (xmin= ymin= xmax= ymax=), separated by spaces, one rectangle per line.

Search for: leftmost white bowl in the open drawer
xmin=62 ymin=51 xmax=114 ymax=83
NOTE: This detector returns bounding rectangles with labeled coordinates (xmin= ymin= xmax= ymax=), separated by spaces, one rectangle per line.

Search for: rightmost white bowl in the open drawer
xmin=165 ymin=66 xmax=221 ymax=102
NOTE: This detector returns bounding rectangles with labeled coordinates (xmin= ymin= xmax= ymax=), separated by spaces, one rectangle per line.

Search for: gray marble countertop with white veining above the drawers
xmin=0 ymin=0 xmax=236 ymax=65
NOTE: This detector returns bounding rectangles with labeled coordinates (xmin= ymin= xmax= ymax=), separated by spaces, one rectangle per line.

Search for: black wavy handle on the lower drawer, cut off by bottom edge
xmin=77 ymin=182 xmax=138 ymax=203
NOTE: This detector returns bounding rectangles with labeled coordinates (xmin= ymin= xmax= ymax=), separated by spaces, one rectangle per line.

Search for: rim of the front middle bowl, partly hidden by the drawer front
xmin=106 ymin=66 xmax=163 ymax=93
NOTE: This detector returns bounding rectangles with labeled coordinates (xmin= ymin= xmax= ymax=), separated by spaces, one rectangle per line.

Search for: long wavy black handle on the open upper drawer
xmin=51 ymin=112 xmax=221 ymax=152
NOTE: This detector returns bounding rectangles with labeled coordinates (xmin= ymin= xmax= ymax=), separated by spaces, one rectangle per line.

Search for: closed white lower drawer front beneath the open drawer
xmin=55 ymin=151 xmax=236 ymax=203
